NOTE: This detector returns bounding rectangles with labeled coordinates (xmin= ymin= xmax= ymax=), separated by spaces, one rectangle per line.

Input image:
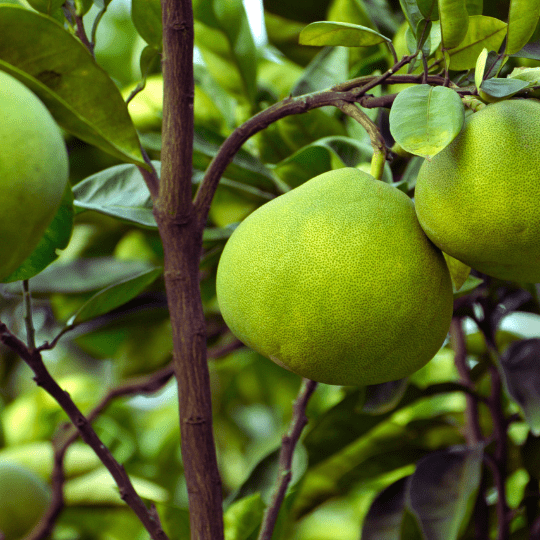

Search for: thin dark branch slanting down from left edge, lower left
xmin=0 ymin=323 xmax=167 ymax=540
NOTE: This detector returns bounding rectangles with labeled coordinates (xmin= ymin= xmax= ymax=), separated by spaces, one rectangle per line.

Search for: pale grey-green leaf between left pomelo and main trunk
xmin=73 ymin=161 xmax=160 ymax=228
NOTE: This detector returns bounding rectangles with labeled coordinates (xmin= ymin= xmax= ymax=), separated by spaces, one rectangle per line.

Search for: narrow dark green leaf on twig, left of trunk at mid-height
xmin=68 ymin=268 xmax=163 ymax=324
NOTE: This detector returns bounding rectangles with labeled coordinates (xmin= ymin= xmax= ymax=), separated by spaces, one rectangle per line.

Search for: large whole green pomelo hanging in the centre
xmin=216 ymin=168 xmax=452 ymax=386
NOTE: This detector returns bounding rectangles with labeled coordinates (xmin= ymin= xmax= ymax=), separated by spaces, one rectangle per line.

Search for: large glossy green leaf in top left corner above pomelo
xmin=0 ymin=4 xmax=146 ymax=167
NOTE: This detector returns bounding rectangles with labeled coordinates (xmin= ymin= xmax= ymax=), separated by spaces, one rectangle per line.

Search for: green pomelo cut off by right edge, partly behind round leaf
xmin=415 ymin=99 xmax=540 ymax=283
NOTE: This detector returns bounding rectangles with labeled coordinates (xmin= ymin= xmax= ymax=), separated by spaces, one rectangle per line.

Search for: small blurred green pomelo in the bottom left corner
xmin=0 ymin=461 xmax=50 ymax=540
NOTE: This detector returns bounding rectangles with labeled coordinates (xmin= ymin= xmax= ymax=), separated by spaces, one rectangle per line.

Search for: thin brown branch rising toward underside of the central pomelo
xmin=258 ymin=379 xmax=317 ymax=540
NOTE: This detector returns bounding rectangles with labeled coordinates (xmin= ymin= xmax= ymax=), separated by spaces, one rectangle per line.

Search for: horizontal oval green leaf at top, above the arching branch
xmin=299 ymin=21 xmax=392 ymax=47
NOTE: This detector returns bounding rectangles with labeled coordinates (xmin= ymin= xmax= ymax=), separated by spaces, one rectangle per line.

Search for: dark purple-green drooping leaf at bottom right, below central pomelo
xmin=408 ymin=446 xmax=483 ymax=540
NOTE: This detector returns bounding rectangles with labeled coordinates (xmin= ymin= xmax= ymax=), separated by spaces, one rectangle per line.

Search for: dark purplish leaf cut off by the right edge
xmin=501 ymin=338 xmax=540 ymax=435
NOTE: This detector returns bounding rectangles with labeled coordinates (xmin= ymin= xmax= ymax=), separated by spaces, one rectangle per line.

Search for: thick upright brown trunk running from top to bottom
xmin=154 ymin=0 xmax=223 ymax=540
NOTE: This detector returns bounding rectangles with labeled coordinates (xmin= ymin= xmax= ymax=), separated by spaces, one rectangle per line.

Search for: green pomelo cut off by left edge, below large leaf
xmin=0 ymin=71 xmax=68 ymax=280
